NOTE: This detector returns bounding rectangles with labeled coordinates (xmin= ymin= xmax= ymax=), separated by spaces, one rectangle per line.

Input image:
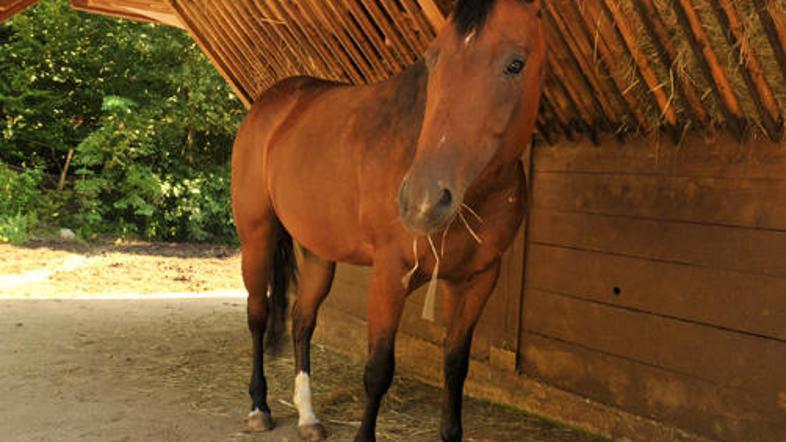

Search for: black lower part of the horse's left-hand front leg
xmin=355 ymin=335 xmax=395 ymax=442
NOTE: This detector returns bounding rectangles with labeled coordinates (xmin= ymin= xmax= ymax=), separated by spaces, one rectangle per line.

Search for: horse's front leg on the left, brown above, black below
xmin=355 ymin=259 xmax=407 ymax=442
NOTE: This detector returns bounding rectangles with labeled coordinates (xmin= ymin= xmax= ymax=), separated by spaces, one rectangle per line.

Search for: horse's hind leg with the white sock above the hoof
xmin=292 ymin=249 xmax=336 ymax=442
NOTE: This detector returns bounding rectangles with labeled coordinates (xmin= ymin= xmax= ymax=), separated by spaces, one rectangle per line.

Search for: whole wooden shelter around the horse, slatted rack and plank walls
xmin=0 ymin=0 xmax=786 ymax=441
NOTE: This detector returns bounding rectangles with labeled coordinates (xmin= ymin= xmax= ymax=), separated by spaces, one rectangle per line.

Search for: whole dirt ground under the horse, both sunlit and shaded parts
xmin=0 ymin=243 xmax=601 ymax=441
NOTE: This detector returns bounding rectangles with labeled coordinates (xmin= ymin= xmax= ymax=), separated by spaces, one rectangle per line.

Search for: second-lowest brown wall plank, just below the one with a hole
xmin=524 ymin=289 xmax=786 ymax=398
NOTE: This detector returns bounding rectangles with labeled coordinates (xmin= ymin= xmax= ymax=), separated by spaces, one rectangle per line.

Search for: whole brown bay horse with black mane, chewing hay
xmin=232 ymin=0 xmax=546 ymax=441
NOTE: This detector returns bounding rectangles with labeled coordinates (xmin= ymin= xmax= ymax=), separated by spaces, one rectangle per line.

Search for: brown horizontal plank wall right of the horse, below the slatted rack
xmin=519 ymin=137 xmax=786 ymax=442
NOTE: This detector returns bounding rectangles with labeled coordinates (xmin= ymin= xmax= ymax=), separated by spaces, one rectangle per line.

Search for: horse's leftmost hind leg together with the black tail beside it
xmin=238 ymin=212 xmax=294 ymax=431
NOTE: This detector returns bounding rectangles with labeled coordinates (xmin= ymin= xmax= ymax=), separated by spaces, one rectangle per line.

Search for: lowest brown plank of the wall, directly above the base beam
xmin=524 ymin=334 xmax=786 ymax=442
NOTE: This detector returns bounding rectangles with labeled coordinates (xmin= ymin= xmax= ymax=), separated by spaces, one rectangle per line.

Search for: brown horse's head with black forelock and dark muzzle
xmin=398 ymin=0 xmax=546 ymax=235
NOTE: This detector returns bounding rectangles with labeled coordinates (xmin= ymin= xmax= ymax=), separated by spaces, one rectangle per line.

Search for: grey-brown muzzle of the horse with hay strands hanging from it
xmin=398 ymin=176 xmax=460 ymax=236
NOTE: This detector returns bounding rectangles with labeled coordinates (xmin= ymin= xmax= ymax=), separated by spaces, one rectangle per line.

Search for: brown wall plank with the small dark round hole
xmin=525 ymin=239 xmax=786 ymax=342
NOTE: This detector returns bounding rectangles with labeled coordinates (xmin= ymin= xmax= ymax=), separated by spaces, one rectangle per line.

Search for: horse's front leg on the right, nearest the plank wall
xmin=440 ymin=261 xmax=499 ymax=442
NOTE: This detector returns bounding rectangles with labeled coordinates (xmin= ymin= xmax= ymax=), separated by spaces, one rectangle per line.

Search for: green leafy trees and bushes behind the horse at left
xmin=0 ymin=0 xmax=244 ymax=241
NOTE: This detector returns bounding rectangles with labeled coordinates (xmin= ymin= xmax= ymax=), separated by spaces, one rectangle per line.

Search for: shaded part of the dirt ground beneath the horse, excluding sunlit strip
xmin=0 ymin=299 xmax=601 ymax=442
